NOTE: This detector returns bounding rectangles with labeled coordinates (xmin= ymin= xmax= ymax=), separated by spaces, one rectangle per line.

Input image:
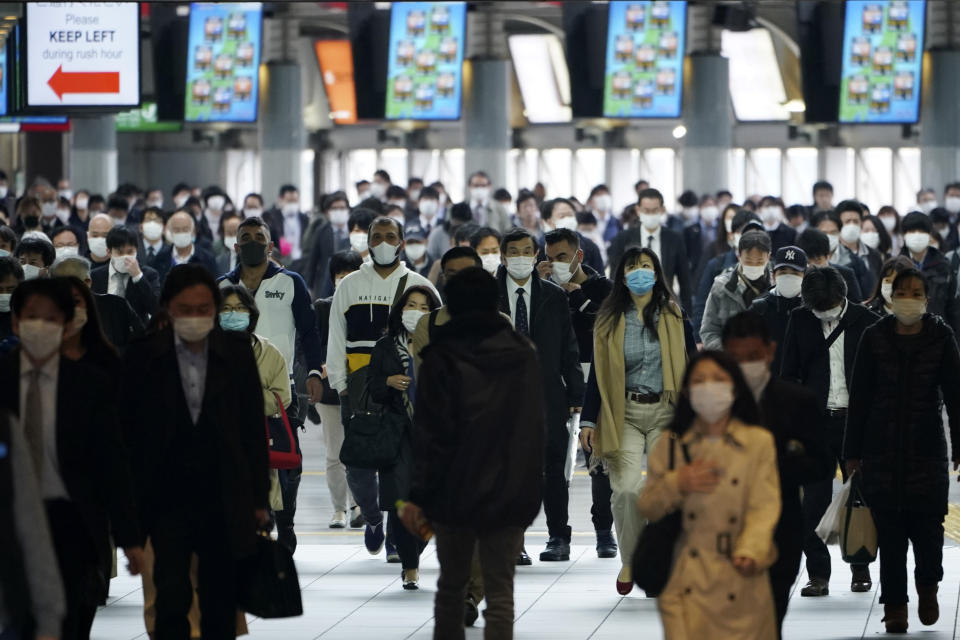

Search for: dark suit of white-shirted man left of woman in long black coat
xmin=781 ymin=301 xmax=878 ymax=580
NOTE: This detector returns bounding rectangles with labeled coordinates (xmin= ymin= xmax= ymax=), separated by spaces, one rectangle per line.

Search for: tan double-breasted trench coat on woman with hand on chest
xmin=638 ymin=421 xmax=780 ymax=640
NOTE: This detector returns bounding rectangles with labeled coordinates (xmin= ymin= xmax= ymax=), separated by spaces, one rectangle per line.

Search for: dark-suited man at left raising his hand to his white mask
xmin=90 ymin=223 xmax=160 ymax=324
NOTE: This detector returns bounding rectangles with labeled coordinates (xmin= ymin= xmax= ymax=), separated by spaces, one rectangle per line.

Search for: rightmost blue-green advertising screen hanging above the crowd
xmin=839 ymin=0 xmax=926 ymax=124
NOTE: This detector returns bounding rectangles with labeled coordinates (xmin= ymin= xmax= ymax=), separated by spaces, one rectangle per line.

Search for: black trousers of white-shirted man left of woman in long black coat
xmin=803 ymin=415 xmax=869 ymax=580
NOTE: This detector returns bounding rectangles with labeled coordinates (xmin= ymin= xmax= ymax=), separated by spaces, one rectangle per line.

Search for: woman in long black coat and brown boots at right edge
xmin=843 ymin=268 xmax=960 ymax=633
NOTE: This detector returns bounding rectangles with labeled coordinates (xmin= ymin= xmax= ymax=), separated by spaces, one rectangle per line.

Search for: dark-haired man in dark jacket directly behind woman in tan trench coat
xmin=723 ymin=310 xmax=835 ymax=629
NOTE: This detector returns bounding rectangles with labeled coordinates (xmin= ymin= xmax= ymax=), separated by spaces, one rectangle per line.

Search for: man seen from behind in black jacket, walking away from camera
xmin=401 ymin=268 xmax=544 ymax=639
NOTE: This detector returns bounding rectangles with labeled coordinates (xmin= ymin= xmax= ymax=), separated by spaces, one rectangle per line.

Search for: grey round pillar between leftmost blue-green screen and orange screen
xmin=259 ymin=62 xmax=307 ymax=207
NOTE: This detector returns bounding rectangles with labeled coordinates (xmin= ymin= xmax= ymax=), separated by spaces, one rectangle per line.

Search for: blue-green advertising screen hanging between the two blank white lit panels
xmin=603 ymin=1 xmax=687 ymax=118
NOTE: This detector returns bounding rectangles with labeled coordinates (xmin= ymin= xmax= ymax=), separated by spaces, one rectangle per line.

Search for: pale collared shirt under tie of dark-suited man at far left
xmin=20 ymin=350 xmax=70 ymax=500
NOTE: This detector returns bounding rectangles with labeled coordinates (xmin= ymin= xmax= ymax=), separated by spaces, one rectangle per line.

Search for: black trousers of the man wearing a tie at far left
xmin=45 ymin=500 xmax=100 ymax=640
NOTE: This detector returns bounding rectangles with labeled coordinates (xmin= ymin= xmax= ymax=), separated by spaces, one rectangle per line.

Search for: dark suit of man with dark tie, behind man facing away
xmin=497 ymin=269 xmax=585 ymax=544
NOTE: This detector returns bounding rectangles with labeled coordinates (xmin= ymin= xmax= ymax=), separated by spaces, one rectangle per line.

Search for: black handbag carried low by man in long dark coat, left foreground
xmin=237 ymin=532 xmax=303 ymax=618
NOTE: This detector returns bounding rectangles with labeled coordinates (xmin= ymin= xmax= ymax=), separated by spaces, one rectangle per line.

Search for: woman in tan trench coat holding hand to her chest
xmin=637 ymin=351 xmax=780 ymax=640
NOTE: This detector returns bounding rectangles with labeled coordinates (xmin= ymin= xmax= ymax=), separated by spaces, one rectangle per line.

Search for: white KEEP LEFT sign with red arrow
xmin=26 ymin=2 xmax=140 ymax=108
